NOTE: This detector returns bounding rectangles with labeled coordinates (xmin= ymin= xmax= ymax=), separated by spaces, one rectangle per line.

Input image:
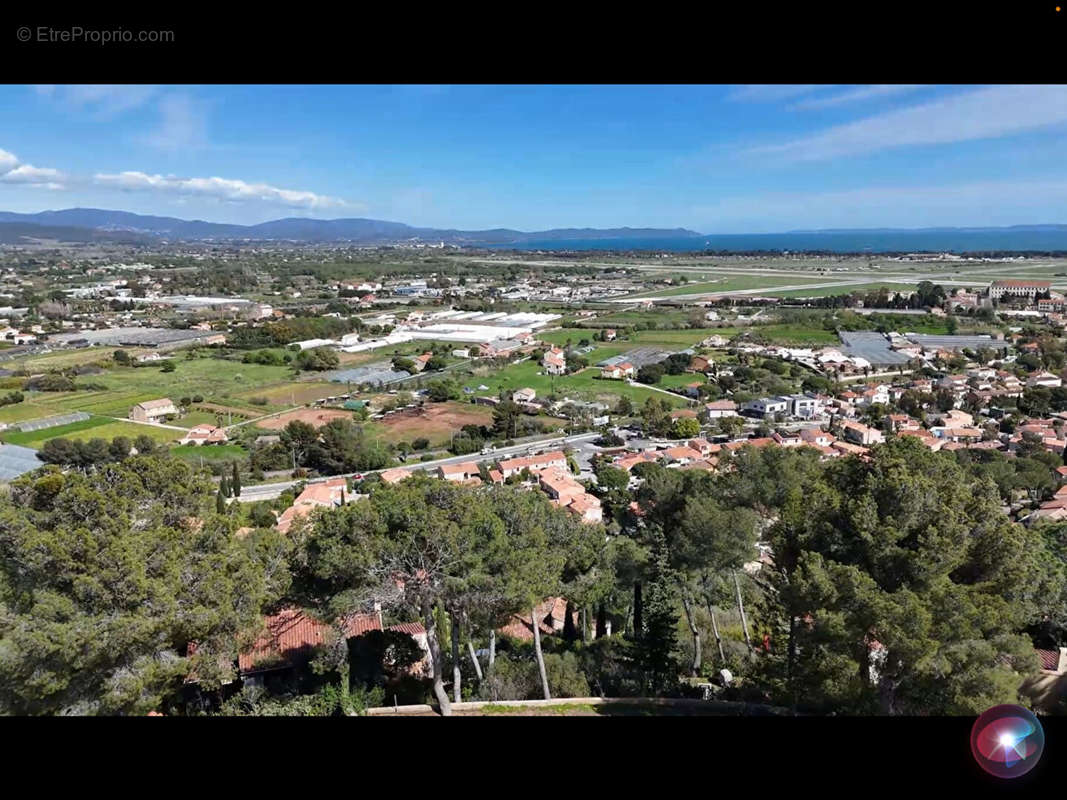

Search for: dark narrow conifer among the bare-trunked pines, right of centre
xmin=637 ymin=526 xmax=679 ymax=694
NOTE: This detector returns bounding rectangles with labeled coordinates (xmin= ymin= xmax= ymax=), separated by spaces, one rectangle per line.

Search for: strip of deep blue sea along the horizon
xmin=492 ymin=229 xmax=1067 ymax=254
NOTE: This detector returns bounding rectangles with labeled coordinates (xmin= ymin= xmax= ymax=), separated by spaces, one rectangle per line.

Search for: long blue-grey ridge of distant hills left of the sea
xmin=0 ymin=208 xmax=700 ymax=245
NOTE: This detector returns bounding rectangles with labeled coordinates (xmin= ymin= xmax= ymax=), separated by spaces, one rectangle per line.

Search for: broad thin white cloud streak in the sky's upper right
xmin=748 ymin=85 xmax=1067 ymax=161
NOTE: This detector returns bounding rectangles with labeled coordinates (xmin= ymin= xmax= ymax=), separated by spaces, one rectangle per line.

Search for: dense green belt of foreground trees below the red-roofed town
xmin=0 ymin=435 xmax=1067 ymax=715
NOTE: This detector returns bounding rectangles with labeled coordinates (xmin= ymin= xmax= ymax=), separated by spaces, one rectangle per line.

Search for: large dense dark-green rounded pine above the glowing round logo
xmin=767 ymin=438 xmax=1062 ymax=714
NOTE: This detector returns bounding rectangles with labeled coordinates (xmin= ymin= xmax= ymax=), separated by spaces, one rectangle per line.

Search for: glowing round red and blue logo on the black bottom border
xmin=971 ymin=705 xmax=1045 ymax=778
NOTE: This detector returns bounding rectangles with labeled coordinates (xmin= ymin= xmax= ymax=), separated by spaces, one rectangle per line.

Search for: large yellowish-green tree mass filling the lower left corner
xmin=0 ymin=455 xmax=288 ymax=715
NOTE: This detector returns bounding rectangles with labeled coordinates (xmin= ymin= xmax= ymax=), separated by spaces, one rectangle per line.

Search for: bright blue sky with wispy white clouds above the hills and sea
xmin=0 ymin=84 xmax=1067 ymax=234
